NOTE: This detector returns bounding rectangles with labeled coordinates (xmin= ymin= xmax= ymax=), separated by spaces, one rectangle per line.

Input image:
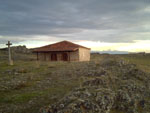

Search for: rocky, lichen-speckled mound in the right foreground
xmin=40 ymin=58 xmax=150 ymax=113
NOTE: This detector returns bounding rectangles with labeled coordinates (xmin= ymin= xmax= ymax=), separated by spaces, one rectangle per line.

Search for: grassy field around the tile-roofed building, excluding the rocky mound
xmin=0 ymin=51 xmax=150 ymax=113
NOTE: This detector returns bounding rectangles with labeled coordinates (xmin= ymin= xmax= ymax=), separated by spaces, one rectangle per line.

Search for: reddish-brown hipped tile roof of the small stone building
xmin=34 ymin=41 xmax=90 ymax=52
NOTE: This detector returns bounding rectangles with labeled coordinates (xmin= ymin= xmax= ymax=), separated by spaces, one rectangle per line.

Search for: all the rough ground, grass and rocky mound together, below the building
xmin=0 ymin=51 xmax=150 ymax=113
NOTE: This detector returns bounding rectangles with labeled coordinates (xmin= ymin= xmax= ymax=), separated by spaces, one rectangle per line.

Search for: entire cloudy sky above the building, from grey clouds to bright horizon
xmin=0 ymin=0 xmax=150 ymax=52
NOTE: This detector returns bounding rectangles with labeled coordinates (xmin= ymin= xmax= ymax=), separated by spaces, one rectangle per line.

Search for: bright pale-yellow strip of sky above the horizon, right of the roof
xmin=76 ymin=40 xmax=150 ymax=52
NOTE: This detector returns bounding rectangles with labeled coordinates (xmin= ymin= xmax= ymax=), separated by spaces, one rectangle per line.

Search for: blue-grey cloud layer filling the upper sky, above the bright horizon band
xmin=0 ymin=0 xmax=150 ymax=42
